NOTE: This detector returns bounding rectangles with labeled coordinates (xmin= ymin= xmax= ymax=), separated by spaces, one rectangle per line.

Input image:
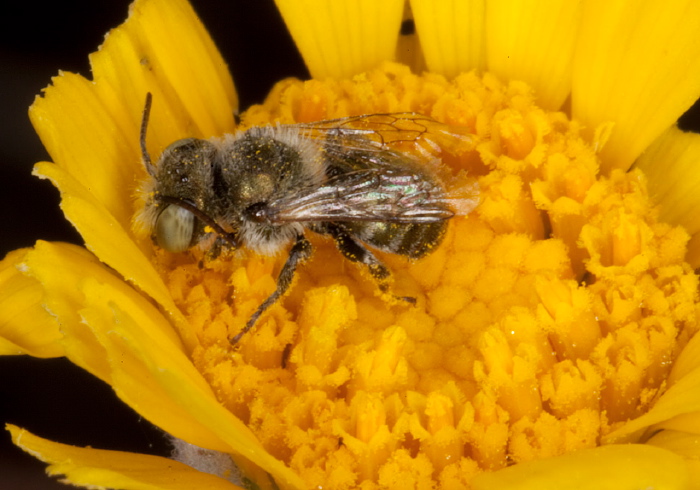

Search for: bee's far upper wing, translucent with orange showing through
xmin=296 ymin=112 xmax=475 ymax=158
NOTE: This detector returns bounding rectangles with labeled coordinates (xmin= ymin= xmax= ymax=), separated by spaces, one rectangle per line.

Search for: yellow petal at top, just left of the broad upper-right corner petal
xmin=486 ymin=0 xmax=581 ymax=110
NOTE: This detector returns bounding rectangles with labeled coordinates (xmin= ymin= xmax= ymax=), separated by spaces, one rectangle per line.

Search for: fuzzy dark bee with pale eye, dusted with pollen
xmin=136 ymin=93 xmax=478 ymax=345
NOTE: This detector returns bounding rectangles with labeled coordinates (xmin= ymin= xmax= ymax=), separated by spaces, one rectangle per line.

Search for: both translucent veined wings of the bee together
xmin=253 ymin=113 xmax=478 ymax=223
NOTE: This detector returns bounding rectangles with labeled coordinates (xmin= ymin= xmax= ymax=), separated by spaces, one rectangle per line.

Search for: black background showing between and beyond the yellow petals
xmin=0 ymin=0 xmax=700 ymax=489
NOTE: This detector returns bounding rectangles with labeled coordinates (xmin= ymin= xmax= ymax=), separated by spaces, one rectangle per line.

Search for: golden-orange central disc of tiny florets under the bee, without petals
xmin=156 ymin=64 xmax=698 ymax=489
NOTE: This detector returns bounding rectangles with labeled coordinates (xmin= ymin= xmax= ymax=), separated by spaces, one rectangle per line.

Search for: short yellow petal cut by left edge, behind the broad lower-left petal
xmin=0 ymin=249 xmax=64 ymax=357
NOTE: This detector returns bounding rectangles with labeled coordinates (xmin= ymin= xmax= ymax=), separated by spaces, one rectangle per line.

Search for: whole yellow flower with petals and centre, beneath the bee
xmin=0 ymin=0 xmax=700 ymax=489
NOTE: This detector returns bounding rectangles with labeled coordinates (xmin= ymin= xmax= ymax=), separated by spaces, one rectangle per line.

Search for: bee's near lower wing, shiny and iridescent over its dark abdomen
xmin=256 ymin=168 xmax=456 ymax=223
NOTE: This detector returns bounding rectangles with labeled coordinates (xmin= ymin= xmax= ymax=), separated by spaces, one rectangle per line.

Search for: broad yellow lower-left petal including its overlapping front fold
xmin=23 ymin=242 xmax=298 ymax=486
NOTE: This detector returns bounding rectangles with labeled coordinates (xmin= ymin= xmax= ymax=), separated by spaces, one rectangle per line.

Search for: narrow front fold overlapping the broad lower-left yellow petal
xmin=82 ymin=298 xmax=304 ymax=488
